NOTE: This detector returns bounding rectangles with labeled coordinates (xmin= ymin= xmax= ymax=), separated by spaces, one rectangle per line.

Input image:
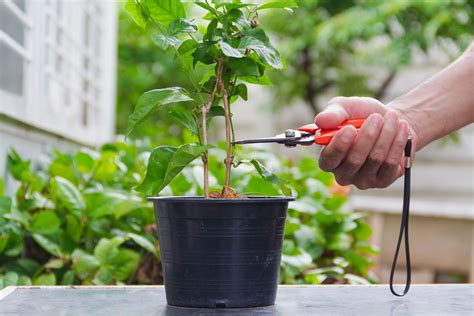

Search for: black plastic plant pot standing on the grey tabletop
xmin=150 ymin=197 xmax=293 ymax=308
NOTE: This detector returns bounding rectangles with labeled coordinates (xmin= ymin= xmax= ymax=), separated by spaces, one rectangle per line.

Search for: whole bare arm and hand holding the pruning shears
xmin=315 ymin=44 xmax=474 ymax=189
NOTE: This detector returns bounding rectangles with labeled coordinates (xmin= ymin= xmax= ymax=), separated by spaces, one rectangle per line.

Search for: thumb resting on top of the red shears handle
xmin=315 ymin=97 xmax=385 ymax=129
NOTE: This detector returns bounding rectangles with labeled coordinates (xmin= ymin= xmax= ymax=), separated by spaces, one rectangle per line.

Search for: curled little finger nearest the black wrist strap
xmin=377 ymin=120 xmax=408 ymax=184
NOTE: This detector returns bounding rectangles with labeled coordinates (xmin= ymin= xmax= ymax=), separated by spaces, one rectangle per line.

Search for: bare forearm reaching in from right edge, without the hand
xmin=389 ymin=44 xmax=474 ymax=149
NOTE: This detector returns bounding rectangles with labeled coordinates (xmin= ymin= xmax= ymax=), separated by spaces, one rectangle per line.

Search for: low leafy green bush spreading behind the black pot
xmin=0 ymin=142 xmax=377 ymax=288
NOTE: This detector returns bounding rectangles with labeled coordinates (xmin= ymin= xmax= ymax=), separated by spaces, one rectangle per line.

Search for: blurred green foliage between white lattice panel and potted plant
xmin=116 ymin=4 xmax=193 ymax=145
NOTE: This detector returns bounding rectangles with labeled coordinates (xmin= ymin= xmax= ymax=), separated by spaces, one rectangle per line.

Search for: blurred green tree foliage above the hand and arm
xmin=263 ymin=0 xmax=474 ymax=113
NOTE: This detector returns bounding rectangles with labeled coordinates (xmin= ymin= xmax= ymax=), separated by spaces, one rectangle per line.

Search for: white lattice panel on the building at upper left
xmin=0 ymin=0 xmax=117 ymax=144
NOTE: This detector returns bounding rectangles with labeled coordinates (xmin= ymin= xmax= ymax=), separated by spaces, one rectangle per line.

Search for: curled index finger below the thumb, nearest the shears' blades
xmin=319 ymin=126 xmax=357 ymax=171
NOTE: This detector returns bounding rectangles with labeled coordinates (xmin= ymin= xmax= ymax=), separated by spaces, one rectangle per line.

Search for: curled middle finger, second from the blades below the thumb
xmin=334 ymin=113 xmax=383 ymax=185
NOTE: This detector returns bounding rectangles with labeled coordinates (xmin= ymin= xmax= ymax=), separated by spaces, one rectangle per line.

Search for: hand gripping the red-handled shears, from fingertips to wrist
xmin=315 ymin=97 xmax=414 ymax=190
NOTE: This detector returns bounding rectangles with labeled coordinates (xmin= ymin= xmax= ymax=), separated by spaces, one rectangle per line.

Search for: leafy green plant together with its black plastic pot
xmin=125 ymin=0 xmax=296 ymax=308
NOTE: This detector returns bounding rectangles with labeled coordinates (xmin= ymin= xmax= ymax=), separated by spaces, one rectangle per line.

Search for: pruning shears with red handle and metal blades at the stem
xmin=234 ymin=119 xmax=365 ymax=147
